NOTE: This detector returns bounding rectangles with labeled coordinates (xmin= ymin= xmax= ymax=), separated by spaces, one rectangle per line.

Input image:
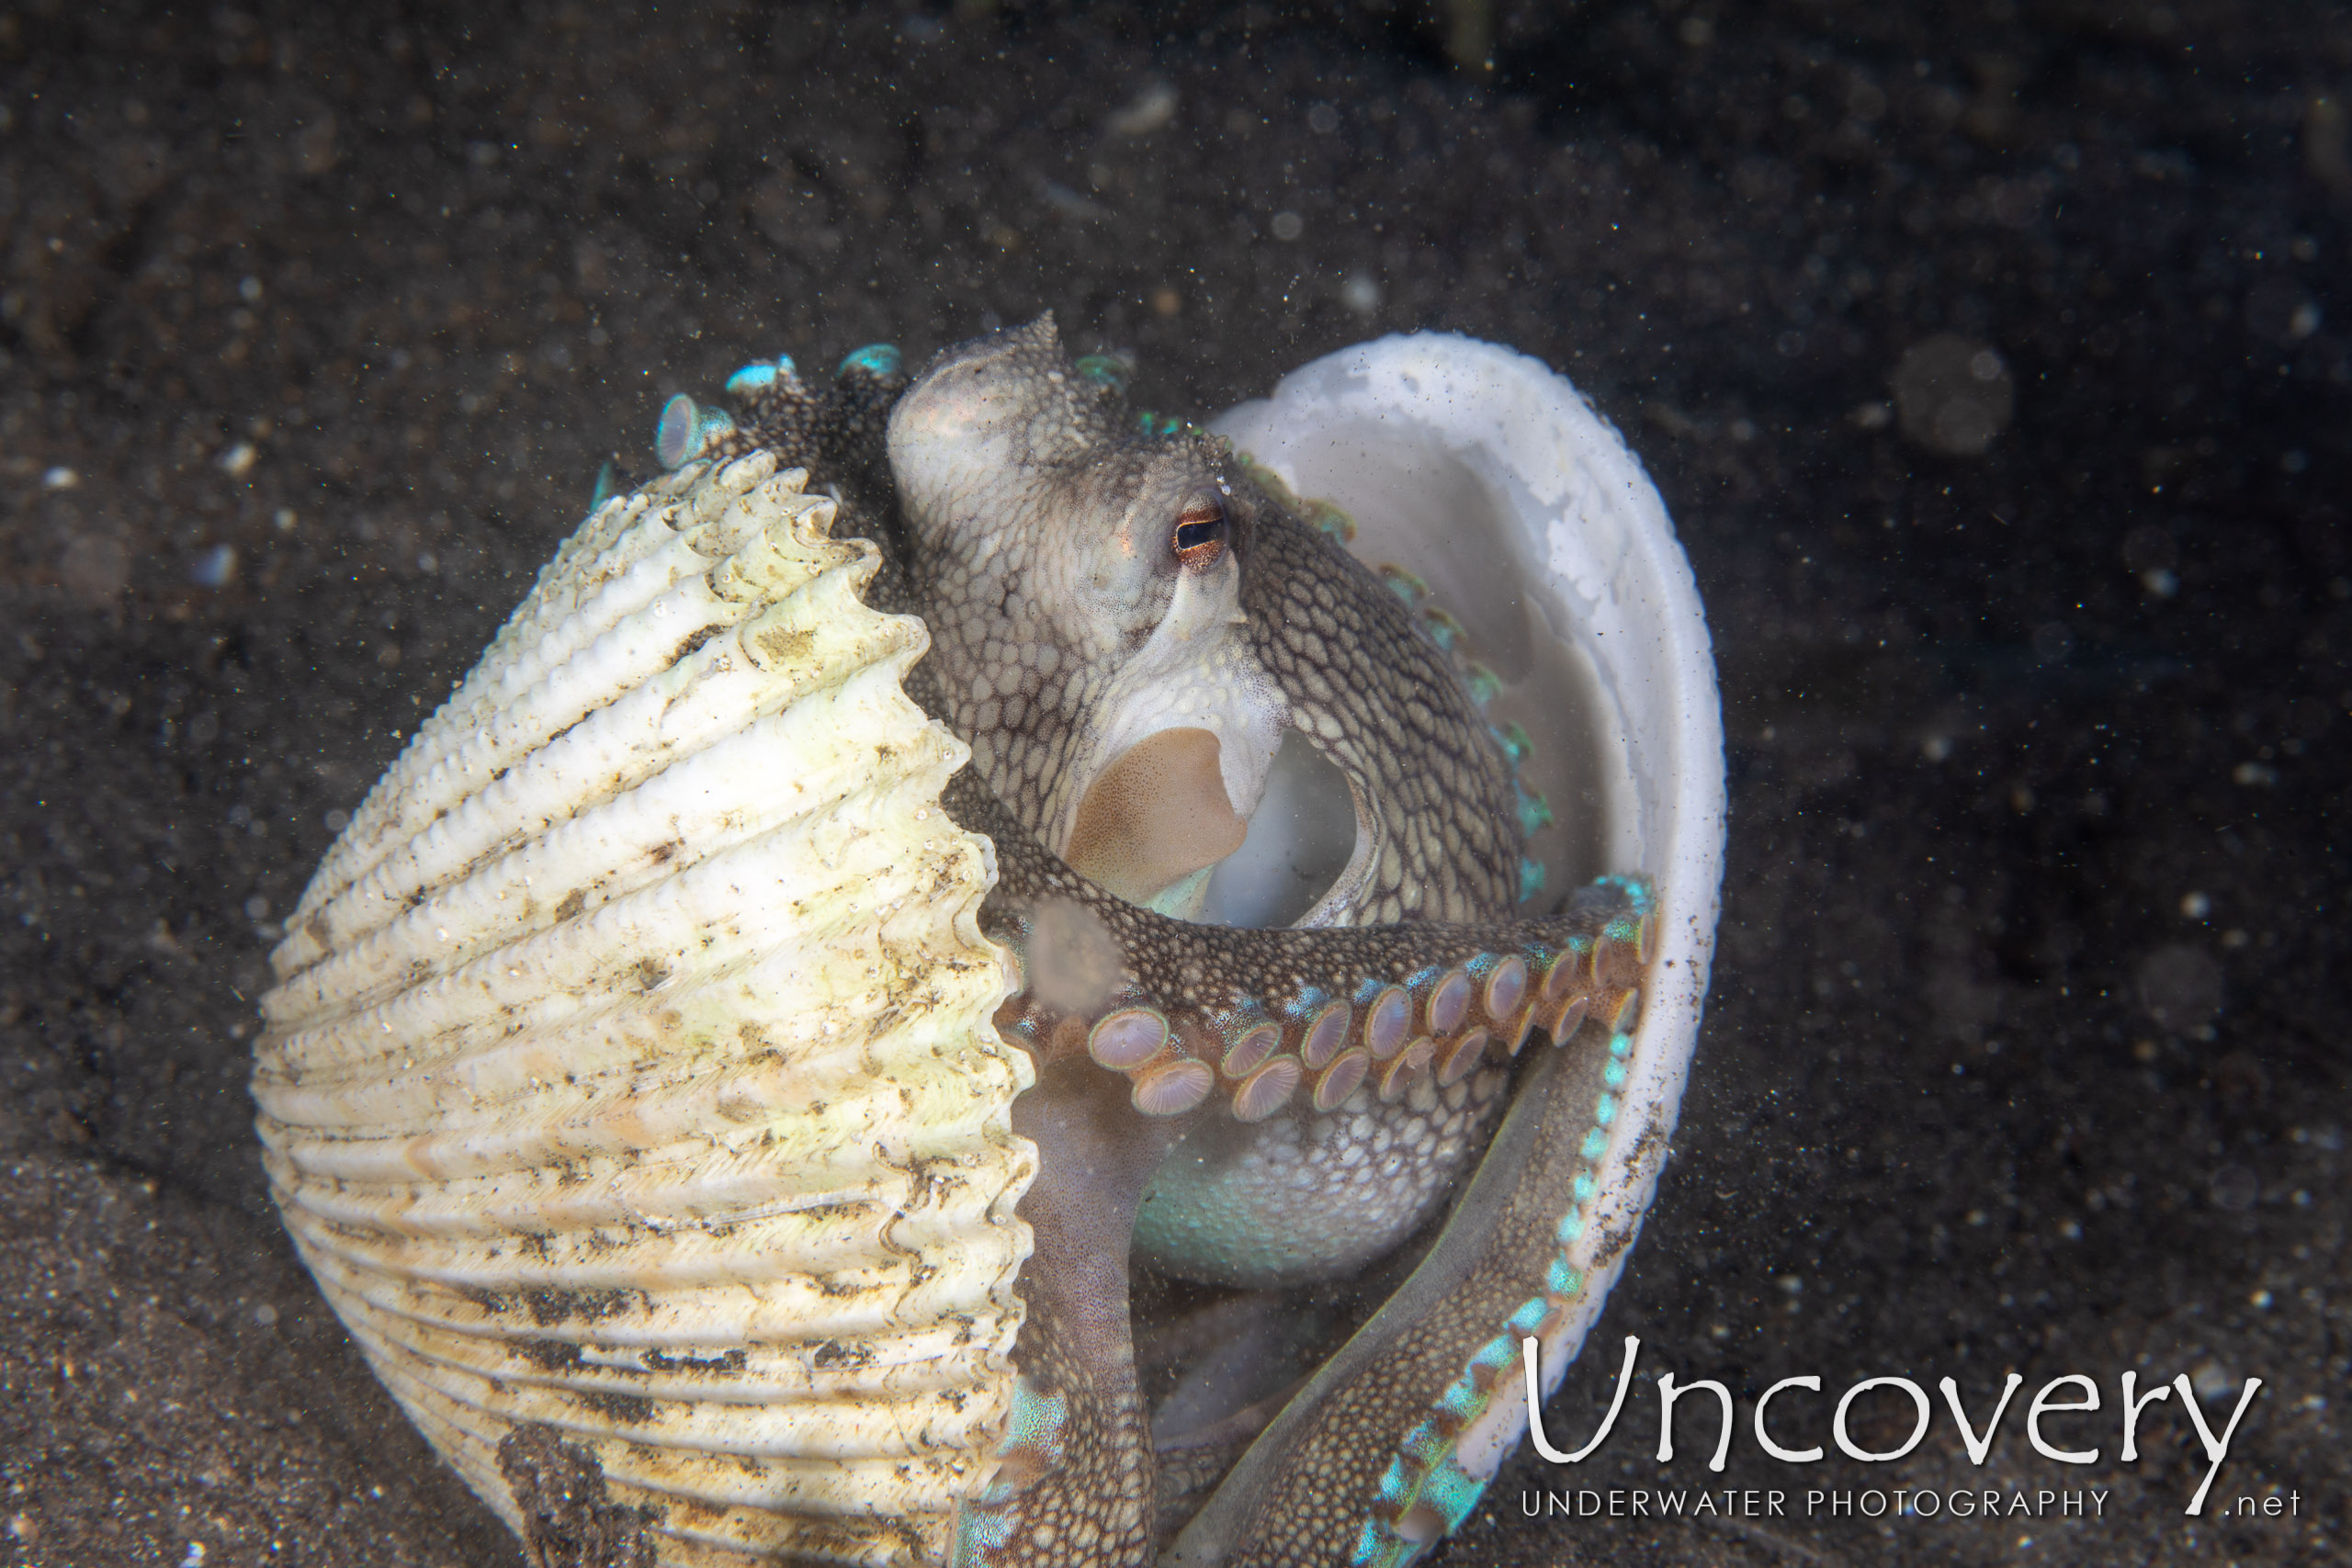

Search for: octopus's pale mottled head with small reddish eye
xmin=889 ymin=315 xmax=1286 ymax=912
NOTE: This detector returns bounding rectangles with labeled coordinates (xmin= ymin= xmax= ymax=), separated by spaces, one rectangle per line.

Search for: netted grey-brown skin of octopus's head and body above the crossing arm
xmin=889 ymin=317 xmax=1520 ymax=924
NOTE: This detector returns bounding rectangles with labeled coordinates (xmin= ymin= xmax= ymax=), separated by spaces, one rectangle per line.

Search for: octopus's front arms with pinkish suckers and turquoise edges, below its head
xmin=941 ymin=769 xmax=1654 ymax=1565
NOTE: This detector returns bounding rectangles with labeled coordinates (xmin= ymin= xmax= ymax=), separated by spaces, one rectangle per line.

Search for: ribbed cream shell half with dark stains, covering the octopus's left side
xmin=254 ymin=454 xmax=1035 ymax=1563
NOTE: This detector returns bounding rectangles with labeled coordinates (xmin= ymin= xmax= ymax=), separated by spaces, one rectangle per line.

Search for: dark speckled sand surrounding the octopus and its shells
xmin=0 ymin=0 xmax=2352 ymax=1565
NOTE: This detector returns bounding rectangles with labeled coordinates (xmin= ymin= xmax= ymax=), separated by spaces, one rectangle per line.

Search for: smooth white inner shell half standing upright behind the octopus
xmin=1211 ymin=332 xmax=1724 ymax=1479
